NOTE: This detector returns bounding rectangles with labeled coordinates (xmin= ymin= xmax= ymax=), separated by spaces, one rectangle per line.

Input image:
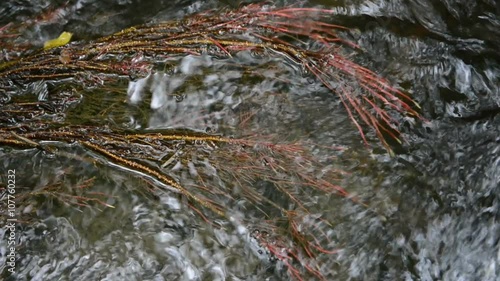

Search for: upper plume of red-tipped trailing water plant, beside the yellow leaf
xmin=0 ymin=4 xmax=419 ymax=149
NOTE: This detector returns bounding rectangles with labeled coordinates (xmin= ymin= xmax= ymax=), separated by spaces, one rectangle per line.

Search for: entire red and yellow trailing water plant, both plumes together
xmin=0 ymin=1 xmax=419 ymax=280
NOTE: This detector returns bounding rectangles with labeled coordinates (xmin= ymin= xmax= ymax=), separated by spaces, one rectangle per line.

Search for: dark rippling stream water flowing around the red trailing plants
xmin=0 ymin=0 xmax=500 ymax=280
